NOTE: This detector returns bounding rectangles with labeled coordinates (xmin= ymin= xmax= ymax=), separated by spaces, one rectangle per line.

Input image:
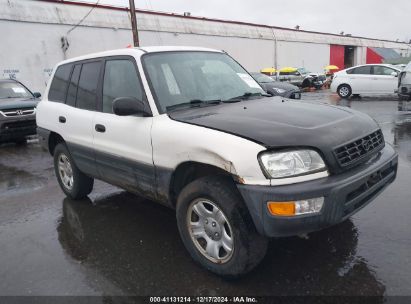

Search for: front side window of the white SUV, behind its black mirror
xmin=103 ymin=59 xmax=144 ymax=113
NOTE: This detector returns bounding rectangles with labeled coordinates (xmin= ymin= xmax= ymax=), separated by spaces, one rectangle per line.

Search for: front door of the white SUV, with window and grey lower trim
xmin=92 ymin=56 xmax=155 ymax=197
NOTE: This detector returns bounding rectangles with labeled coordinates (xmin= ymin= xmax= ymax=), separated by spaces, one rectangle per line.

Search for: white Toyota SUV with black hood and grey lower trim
xmin=37 ymin=47 xmax=397 ymax=277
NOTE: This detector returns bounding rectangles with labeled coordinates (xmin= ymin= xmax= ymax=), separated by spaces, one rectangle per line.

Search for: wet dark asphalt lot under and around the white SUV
xmin=0 ymin=91 xmax=411 ymax=296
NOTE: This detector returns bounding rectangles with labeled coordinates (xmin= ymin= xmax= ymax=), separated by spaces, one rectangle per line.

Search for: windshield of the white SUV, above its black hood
xmin=143 ymin=51 xmax=265 ymax=113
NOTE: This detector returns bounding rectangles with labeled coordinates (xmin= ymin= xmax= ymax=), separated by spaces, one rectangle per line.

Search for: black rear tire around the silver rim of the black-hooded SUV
xmin=54 ymin=143 xmax=94 ymax=200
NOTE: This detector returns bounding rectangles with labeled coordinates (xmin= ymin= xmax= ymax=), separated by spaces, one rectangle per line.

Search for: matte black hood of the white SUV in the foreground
xmin=168 ymin=97 xmax=379 ymax=172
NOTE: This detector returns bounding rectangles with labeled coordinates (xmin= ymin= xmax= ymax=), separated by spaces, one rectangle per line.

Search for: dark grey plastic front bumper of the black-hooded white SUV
xmin=237 ymin=144 xmax=398 ymax=237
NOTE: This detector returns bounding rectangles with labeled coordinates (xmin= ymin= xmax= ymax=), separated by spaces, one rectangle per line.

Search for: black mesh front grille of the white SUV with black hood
xmin=334 ymin=130 xmax=385 ymax=167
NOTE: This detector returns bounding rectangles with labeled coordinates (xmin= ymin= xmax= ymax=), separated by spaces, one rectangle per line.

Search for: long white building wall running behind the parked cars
xmin=0 ymin=0 xmax=410 ymax=91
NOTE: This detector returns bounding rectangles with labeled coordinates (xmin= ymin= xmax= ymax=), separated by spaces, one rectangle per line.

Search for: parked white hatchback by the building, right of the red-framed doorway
xmin=331 ymin=64 xmax=401 ymax=98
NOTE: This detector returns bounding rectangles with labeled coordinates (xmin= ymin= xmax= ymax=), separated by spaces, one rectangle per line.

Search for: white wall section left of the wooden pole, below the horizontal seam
xmin=0 ymin=20 xmax=131 ymax=92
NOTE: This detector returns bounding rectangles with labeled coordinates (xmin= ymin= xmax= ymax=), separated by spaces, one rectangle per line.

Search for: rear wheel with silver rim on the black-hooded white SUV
xmin=54 ymin=143 xmax=94 ymax=200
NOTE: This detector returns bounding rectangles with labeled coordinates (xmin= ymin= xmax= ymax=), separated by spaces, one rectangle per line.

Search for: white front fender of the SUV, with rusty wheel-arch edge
xmin=151 ymin=114 xmax=270 ymax=185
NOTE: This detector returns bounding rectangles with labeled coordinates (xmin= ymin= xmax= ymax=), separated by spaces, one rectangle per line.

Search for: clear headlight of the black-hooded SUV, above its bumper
xmin=260 ymin=150 xmax=326 ymax=178
